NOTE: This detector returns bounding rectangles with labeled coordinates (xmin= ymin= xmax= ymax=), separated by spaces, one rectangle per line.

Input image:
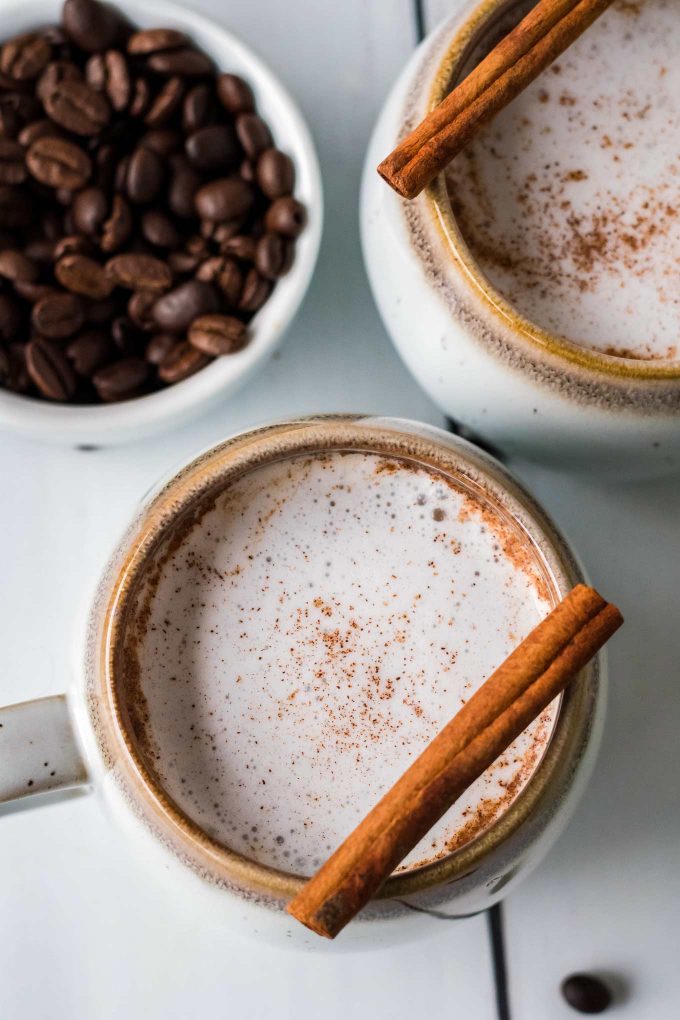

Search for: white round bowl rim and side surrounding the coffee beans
xmin=0 ymin=0 xmax=323 ymax=446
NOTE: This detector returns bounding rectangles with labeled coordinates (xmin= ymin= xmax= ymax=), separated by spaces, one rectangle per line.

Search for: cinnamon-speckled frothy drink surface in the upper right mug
xmin=449 ymin=0 xmax=680 ymax=359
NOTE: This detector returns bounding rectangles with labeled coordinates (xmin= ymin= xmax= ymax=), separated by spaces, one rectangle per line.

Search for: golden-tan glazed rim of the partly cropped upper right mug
xmin=423 ymin=0 xmax=680 ymax=380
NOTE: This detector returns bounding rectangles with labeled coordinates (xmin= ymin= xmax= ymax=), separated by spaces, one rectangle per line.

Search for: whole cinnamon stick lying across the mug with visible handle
xmin=287 ymin=584 xmax=623 ymax=938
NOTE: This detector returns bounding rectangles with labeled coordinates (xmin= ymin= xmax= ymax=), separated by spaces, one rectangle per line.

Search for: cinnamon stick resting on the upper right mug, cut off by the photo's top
xmin=377 ymin=0 xmax=612 ymax=198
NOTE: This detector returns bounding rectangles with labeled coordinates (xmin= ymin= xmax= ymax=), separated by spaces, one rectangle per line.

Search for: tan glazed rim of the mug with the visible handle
xmin=88 ymin=416 xmax=598 ymax=904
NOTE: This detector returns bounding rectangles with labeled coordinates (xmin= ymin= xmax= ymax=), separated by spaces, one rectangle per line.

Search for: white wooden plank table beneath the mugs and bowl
xmin=0 ymin=0 xmax=680 ymax=1020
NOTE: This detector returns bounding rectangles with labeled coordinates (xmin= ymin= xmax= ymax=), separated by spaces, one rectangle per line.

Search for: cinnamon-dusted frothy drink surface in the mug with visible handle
xmin=126 ymin=453 xmax=556 ymax=874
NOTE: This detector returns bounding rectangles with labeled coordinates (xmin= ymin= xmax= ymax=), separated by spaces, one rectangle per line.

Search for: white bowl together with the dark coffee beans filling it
xmin=0 ymin=0 xmax=322 ymax=445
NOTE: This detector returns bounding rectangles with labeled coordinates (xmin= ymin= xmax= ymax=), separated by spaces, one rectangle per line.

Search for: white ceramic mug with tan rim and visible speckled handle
xmin=0 ymin=416 xmax=605 ymax=948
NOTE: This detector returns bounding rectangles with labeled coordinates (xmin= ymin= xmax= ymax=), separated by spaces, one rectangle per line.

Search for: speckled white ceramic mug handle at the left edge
xmin=0 ymin=695 xmax=89 ymax=814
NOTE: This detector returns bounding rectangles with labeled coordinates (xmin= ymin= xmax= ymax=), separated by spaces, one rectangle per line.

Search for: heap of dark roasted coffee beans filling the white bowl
xmin=0 ymin=0 xmax=306 ymax=404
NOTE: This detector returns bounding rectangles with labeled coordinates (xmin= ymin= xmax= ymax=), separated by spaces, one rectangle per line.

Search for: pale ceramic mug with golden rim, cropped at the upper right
xmin=361 ymin=0 xmax=680 ymax=476
